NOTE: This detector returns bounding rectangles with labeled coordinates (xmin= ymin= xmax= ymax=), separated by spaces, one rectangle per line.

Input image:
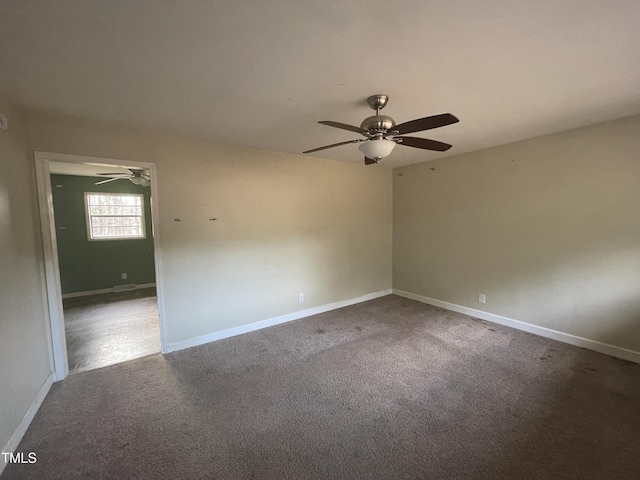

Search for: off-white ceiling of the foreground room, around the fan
xmin=0 ymin=0 xmax=640 ymax=166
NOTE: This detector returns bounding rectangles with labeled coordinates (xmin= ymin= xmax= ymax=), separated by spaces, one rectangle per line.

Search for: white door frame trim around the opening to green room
xmin=34 ymin=152 xmax=167 ymax=381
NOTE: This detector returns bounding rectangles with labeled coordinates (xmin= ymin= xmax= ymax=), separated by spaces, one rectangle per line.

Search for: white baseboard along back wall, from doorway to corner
xmin=163 ymin=289 xmax=391 ymax=353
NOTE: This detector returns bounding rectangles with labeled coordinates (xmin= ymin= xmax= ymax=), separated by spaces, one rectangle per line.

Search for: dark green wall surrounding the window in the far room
xmin=51 ymin=175 xmax=155 ymax=294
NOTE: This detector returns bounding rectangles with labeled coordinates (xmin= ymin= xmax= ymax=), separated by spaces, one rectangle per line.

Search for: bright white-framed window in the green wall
xmin=84 ymin=192 xmax=145 ymax=240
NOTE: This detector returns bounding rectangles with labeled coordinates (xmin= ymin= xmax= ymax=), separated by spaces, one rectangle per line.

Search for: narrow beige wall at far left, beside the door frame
xmin=0 ymin=94 xmax=51 ymax=450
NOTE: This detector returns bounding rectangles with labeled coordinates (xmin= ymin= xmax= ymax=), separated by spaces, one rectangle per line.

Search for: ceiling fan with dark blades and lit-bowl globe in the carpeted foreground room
xmin=302 ymin=95 xmax=459 ymax=165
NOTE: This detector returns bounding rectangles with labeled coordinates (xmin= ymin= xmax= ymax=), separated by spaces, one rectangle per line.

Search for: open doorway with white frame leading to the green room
xmin=35 ymin=152 xmax=165 ymax=380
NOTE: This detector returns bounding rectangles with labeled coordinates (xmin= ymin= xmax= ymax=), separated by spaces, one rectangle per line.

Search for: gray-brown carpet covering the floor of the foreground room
xmin=2 ymin=296 xmax=640 ymax=480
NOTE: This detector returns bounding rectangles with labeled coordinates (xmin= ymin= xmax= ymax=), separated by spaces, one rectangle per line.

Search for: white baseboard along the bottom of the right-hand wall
xmin=393 ymin=288 xmax=640 ymax=363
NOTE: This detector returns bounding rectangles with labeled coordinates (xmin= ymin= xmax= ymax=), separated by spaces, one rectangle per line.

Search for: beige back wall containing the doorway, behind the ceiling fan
xmin=29 ymin=115 xmax=392 ymax=343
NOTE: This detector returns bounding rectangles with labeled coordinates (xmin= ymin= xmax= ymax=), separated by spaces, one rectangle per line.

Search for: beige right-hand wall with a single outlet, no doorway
xmin=393 ymin=117 xmax=640 ymax=351
